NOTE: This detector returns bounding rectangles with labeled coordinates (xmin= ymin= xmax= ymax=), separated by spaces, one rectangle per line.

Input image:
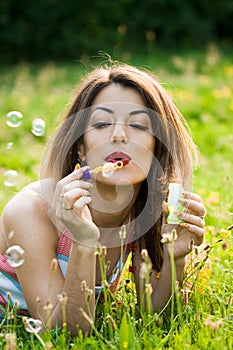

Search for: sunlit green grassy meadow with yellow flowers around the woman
xmin=0 ymin=44 xmax=233 ymax=350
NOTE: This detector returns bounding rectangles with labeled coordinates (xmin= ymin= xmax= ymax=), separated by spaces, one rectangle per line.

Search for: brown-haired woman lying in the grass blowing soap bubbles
xmin=0 ymin=65 xmax=205 ymax=334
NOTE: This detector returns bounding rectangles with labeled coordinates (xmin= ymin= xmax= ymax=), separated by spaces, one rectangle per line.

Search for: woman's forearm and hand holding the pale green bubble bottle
xmin=135 ymin=193 xmax=205 ymax=312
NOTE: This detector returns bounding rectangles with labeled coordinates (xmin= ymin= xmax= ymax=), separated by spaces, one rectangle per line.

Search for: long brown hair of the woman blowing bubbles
xmin=43 ymin=63 xmax=197 ymax=271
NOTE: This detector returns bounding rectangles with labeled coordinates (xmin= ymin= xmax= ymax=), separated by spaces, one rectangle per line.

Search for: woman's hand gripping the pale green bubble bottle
xmin=162 ymin=192 xmax=206 ymax=259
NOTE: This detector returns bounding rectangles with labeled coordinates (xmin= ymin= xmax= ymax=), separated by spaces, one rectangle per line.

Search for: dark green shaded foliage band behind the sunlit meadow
xmin=0 ymin=0 xmax=233 ymax=62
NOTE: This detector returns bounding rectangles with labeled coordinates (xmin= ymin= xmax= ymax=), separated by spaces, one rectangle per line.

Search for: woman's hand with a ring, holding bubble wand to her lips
xmin=52 ymin=167 xmax=100 ymax=246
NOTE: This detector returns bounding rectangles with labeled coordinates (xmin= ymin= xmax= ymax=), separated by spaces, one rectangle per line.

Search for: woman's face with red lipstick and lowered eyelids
xmin=80 ymin=84 xmax=155 ymax=185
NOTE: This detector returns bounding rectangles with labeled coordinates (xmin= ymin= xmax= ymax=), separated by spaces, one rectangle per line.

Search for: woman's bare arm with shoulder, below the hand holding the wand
xmin=2 ymin=191 xmax=95 ymax=334
